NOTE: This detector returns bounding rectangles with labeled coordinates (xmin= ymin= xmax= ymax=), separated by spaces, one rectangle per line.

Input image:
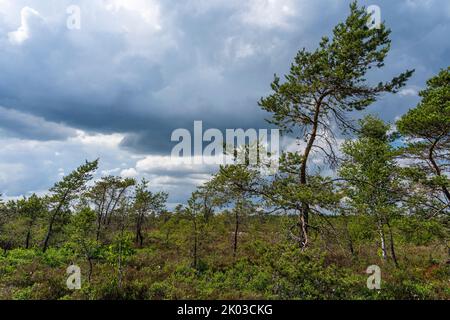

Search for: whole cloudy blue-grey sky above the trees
xmin=0 ymin=0 xmax=450 ymax=205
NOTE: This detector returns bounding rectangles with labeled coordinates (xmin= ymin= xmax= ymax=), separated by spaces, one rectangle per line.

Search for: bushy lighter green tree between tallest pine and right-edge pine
xmin=339 ymin=116 xmax=401 ymax=265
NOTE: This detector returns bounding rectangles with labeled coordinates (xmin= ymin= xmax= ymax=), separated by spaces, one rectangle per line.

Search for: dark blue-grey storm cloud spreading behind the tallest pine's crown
xmin=0 ymin=1 xmax=450 ymax=152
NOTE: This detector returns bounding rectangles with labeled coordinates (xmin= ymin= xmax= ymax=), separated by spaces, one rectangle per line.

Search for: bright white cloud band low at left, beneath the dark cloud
xmin=0 ymin=133 xmax=134 ymax=196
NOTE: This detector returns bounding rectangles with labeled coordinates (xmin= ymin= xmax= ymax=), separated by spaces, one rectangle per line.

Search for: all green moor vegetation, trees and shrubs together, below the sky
xmin=0 ymin=3 xmax=450 ymax=299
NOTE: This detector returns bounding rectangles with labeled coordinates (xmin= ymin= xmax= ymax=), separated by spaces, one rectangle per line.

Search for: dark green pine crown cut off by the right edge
xmin=397 ymin=67 xmax=450 ymax=213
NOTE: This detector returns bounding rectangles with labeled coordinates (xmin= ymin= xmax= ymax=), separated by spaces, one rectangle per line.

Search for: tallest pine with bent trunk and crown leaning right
xmin=259 ymin=2 xmax=413 ymax=248
